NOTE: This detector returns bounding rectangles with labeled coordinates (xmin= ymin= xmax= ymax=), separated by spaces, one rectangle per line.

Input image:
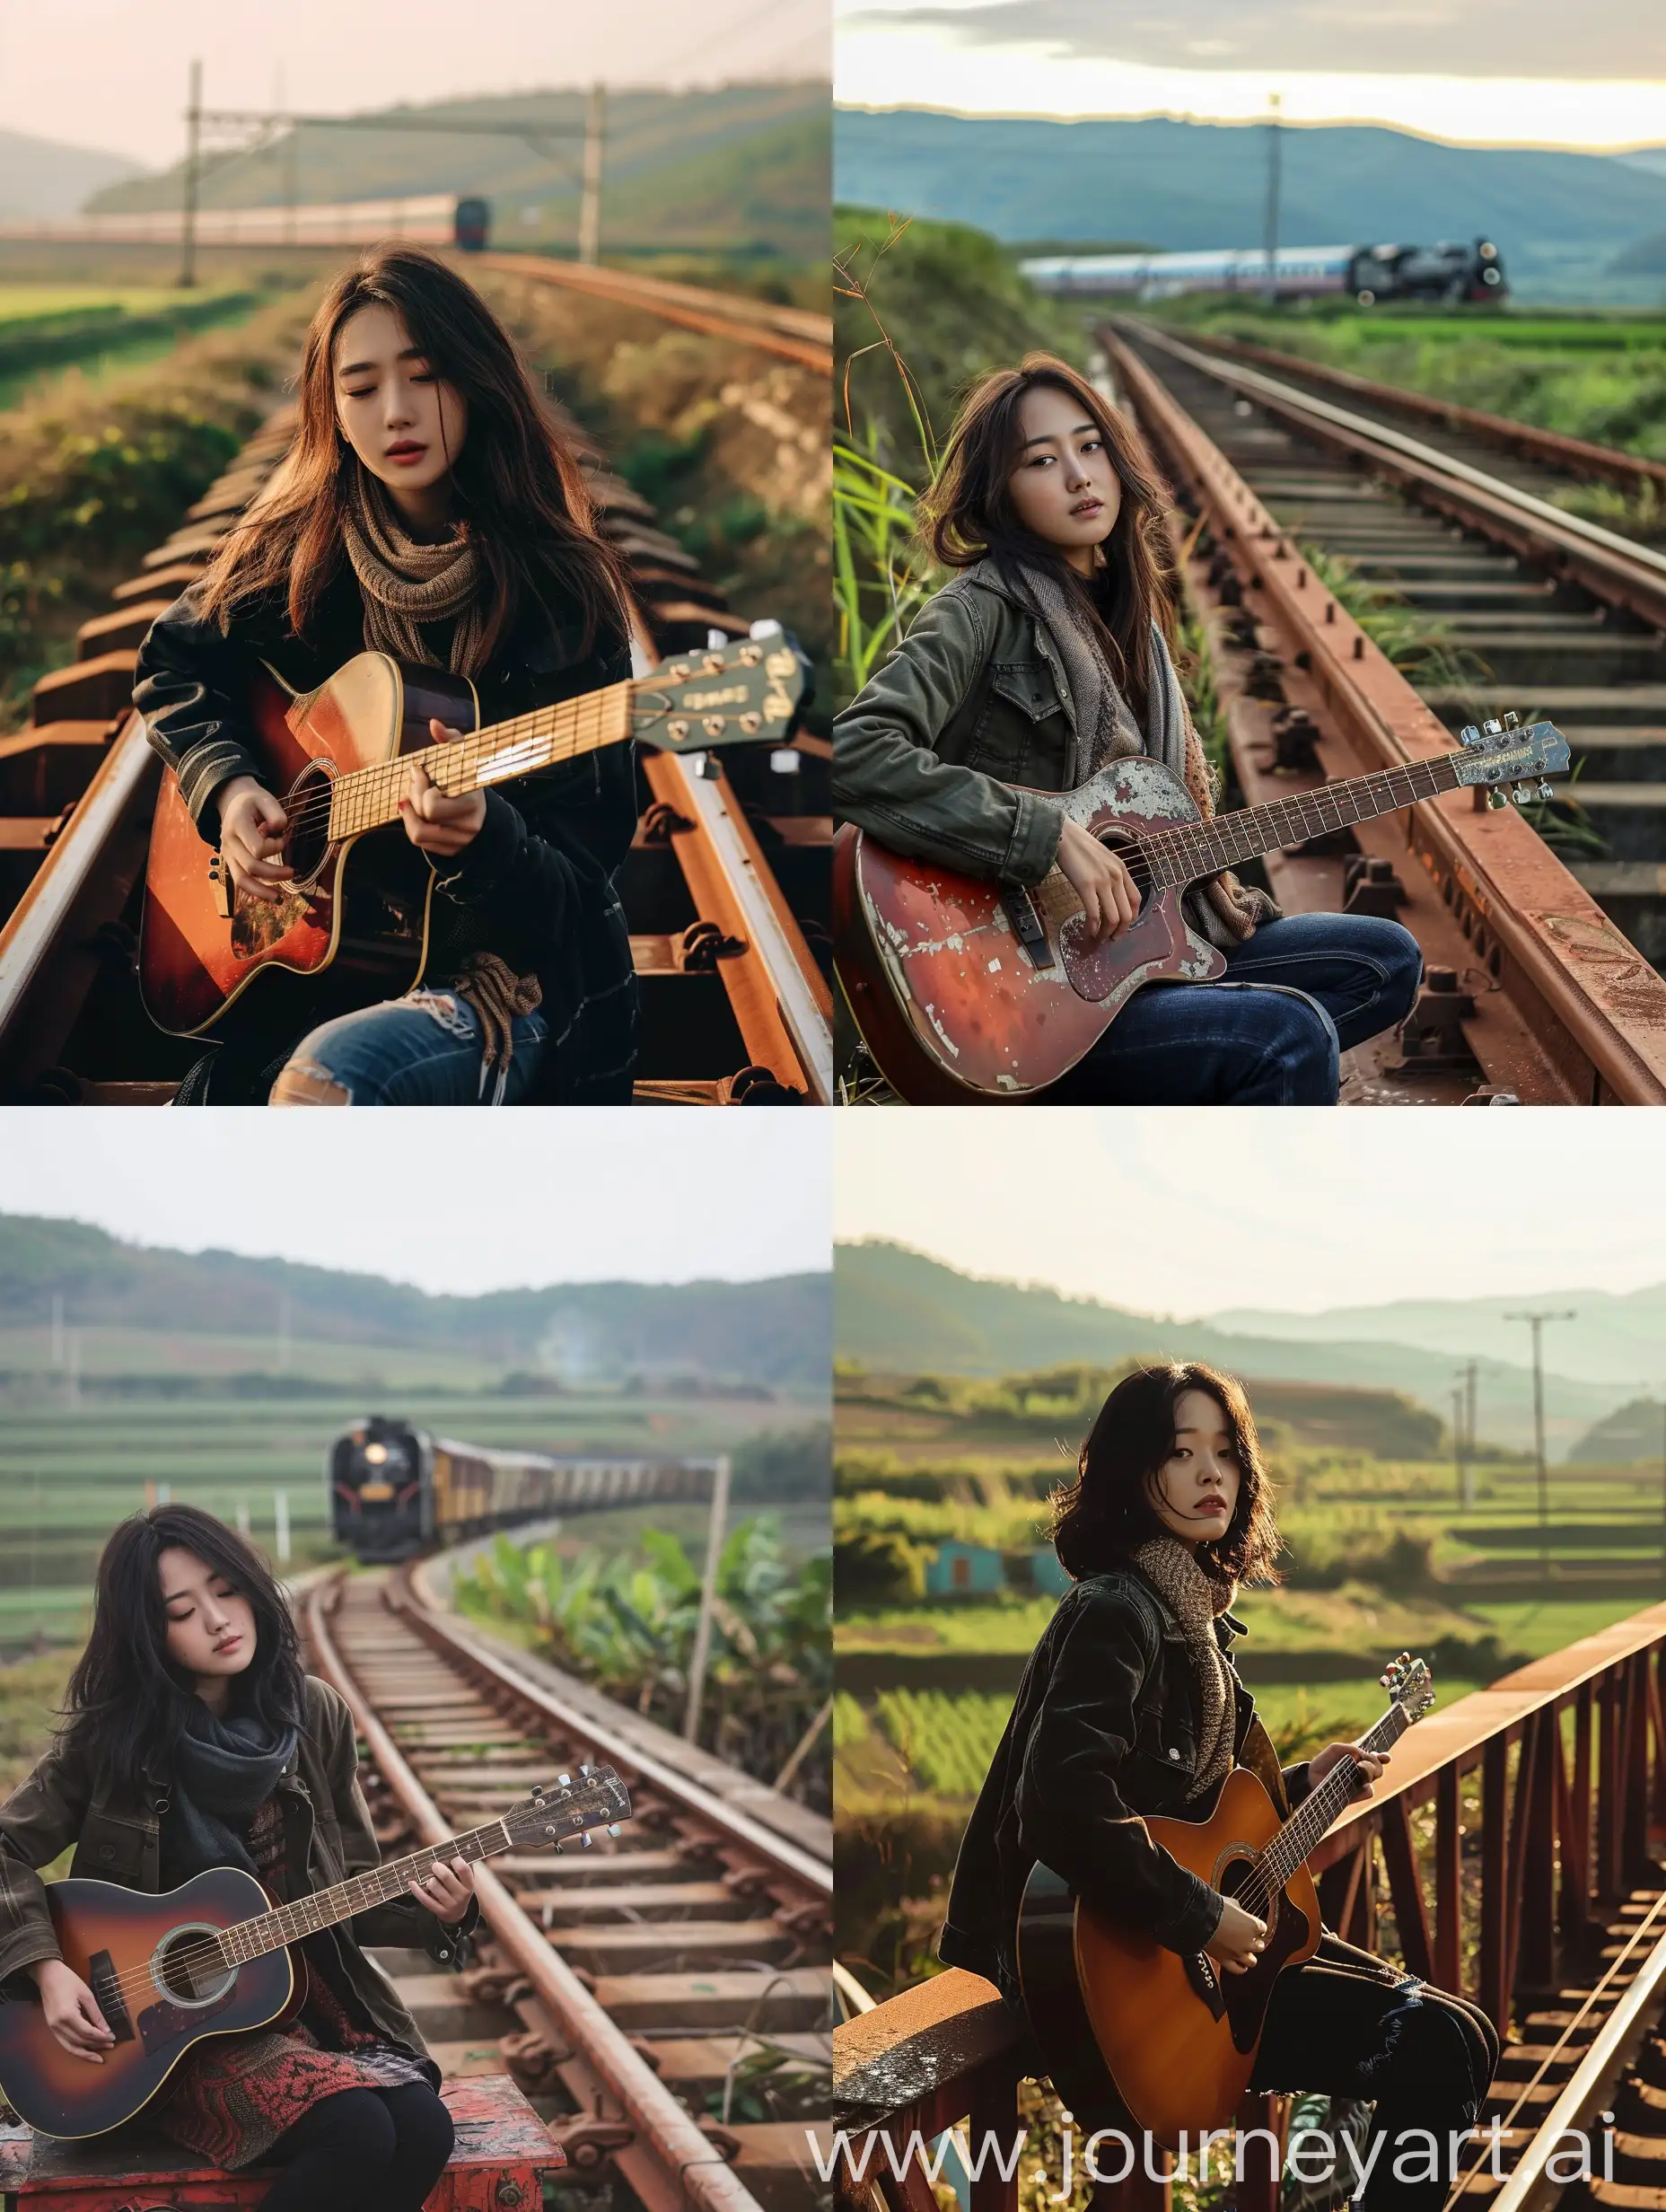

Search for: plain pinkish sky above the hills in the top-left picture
xmin=0 ymin=0 xmax=829 ymax=168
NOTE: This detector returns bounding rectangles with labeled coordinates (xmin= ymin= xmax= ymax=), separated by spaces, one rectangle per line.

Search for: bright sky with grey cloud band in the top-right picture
xmin=834 ymin=0 xmax=1666 ymax=148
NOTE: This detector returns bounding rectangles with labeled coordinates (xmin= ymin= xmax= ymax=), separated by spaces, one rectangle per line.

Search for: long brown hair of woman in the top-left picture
xmin=199 ymin=246 xmax=624 ymax=657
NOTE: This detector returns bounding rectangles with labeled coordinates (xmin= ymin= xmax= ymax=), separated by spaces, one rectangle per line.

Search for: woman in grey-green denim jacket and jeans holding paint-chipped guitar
xmin=834 ymin=354 xmax=1423 ymax=1106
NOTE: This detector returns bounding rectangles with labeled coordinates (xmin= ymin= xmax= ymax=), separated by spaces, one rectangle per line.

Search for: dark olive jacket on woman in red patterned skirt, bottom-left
xmin=0 ymin=1674 xmax=480 ymax=2086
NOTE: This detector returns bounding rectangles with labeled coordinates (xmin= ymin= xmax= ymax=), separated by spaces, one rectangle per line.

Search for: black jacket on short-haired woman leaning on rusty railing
xmin=938 ymin=1568 xmax=1308 ymax=2004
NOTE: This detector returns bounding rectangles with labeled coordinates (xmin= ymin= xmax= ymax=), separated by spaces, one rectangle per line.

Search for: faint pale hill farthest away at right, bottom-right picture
xmin=1208 ymin=1283 xmax=1666 ymax=1387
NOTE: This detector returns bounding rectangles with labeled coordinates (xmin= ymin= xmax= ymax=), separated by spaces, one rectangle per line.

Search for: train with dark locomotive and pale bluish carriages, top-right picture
xmin=1018 ymin=239 xmax=1509 ymax=307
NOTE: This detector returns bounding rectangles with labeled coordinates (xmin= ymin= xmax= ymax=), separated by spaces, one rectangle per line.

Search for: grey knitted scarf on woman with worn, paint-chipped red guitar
xmin=1018 ymin=562 xmax=1279 ymax=952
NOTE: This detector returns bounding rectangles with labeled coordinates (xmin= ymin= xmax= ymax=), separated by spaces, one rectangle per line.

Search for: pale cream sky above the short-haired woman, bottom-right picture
xmin=834 ymin=1123 xmax=1666 ymax=1319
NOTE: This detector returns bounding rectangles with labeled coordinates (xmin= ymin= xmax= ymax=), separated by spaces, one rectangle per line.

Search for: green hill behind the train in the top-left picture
xmin=91 ymin=80 xmax=832 ymax=259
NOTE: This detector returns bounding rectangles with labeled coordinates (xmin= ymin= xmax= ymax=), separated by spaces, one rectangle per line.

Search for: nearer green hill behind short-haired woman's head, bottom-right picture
xmin=834 ymin=1241 xmax=1627 ymax=1460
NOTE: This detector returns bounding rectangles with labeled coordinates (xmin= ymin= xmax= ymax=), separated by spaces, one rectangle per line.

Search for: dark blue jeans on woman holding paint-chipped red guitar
xmin=1038 ymin=914 xmax=1423 ymax=1106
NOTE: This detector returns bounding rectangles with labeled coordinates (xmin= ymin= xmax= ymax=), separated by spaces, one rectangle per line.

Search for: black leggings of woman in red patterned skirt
xmin=261 ymin=2082 xmax=452 ymax=2212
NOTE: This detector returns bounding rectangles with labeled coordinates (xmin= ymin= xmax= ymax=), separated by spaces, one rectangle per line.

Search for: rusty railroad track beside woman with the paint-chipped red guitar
xmin=1101 ymin=316 xmax=1666 ymax=1104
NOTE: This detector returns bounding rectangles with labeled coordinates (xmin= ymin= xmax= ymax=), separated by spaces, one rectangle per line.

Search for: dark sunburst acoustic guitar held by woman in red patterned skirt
xmin=0 ymin=1765 xmax=630 ymax=2139
